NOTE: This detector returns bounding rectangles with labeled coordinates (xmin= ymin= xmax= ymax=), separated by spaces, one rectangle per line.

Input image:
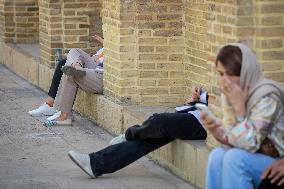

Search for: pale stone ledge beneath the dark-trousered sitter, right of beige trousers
xmin=74 ymin=90 xmax=209 ymax=188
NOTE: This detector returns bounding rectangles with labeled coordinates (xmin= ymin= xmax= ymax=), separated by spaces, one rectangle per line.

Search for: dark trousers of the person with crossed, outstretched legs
xmin=90 ymin=113 xmax=207 ymax=176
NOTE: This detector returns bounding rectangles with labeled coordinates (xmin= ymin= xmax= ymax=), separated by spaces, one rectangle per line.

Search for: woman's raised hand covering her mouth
xmin=220 ymin=77 xmax=249 ymax=116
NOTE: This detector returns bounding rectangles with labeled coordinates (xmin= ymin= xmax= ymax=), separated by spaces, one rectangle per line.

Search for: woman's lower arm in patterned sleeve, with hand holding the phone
xmin=202 ymin=95 xmax=283 ymax=148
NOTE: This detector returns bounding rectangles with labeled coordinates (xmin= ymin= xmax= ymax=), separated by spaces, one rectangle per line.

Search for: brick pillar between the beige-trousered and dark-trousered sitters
xmin=103 ymin=0 xmax=138 ymax=102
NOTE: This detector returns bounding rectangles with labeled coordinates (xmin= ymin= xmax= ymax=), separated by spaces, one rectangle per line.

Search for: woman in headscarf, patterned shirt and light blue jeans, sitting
xmin=202 ymin=43 xmax=284 ymax=189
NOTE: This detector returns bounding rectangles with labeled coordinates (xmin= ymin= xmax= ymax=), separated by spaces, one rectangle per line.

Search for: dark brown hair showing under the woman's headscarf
xmin=215 ymin=45 xmax=242 ymax=76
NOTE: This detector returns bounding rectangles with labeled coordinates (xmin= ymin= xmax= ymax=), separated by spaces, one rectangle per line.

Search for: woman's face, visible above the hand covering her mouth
xmin=216 ymin=61 xmax=240 ymax=86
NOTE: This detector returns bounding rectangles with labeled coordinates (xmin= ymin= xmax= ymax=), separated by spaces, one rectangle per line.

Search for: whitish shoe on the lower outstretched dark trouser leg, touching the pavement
xmin=68 ymin=150 xmax=96 ymax=178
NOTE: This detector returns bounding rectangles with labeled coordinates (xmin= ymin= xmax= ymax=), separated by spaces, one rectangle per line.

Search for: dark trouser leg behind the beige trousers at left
xmin=48 ymin=59 xmax=66 ymax=99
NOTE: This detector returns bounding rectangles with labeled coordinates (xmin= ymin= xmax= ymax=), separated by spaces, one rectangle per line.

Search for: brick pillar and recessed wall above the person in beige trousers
xmin=39 ymin=0 xmax=102 ymax=67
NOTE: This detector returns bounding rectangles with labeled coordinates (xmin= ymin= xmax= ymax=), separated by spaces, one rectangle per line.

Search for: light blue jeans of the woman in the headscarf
xmin=205 ymin=147 xmax=275 ymax=189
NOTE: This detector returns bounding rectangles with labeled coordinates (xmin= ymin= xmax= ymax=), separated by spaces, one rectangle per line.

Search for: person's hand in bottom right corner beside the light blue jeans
xmin=261 ymin=158 xmax=284 ymax=186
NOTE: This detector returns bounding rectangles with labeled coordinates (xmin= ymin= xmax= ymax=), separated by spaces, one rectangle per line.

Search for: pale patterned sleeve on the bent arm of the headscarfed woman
xmin=224 ymin=94 xmax=281 ymax=152
